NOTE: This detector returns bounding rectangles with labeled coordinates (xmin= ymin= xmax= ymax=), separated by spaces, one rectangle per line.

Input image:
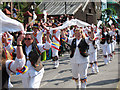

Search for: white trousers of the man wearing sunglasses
xmin=21 ymin=68 xmax=44 ymax=88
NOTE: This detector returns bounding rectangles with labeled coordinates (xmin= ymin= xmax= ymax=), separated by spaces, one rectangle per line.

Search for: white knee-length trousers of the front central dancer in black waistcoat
xmin=71 ymin=62 xmax=88 ymax=79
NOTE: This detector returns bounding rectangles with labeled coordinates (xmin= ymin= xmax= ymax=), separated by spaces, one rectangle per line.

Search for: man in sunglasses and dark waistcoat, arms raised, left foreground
xmin=6 ymin=29 xmax=51 ymax=88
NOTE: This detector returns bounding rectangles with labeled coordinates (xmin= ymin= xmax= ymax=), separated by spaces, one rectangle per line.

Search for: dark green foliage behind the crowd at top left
xmin=3 ymin=0 xmax=42 ymax=23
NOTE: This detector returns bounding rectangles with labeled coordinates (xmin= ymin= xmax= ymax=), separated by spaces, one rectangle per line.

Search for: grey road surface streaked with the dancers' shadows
xmin=11 ymin=45 xmax=120 ymax=90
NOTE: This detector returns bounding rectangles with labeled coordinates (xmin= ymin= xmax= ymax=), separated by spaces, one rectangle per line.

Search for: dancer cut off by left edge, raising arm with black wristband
xmin=2 ymin=32 xmax=26 ymax=89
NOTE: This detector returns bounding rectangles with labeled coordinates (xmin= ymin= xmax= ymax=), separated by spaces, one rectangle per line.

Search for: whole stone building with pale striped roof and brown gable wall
xmin=38 ymin=0 xmax=102 ymax=24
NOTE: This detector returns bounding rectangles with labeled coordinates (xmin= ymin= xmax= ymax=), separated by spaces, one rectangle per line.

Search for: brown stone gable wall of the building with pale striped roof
xmin=74 ymin=2 xmax=102 ymax=24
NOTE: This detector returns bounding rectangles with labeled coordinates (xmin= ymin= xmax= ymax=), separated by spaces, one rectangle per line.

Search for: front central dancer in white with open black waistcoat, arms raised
xmin=62 ymin=28 xmax=93 ymax=88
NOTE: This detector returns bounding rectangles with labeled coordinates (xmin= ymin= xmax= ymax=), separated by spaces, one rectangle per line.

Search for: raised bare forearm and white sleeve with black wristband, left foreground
xmin=6 ymin=34 xmax=26 ymax=72
